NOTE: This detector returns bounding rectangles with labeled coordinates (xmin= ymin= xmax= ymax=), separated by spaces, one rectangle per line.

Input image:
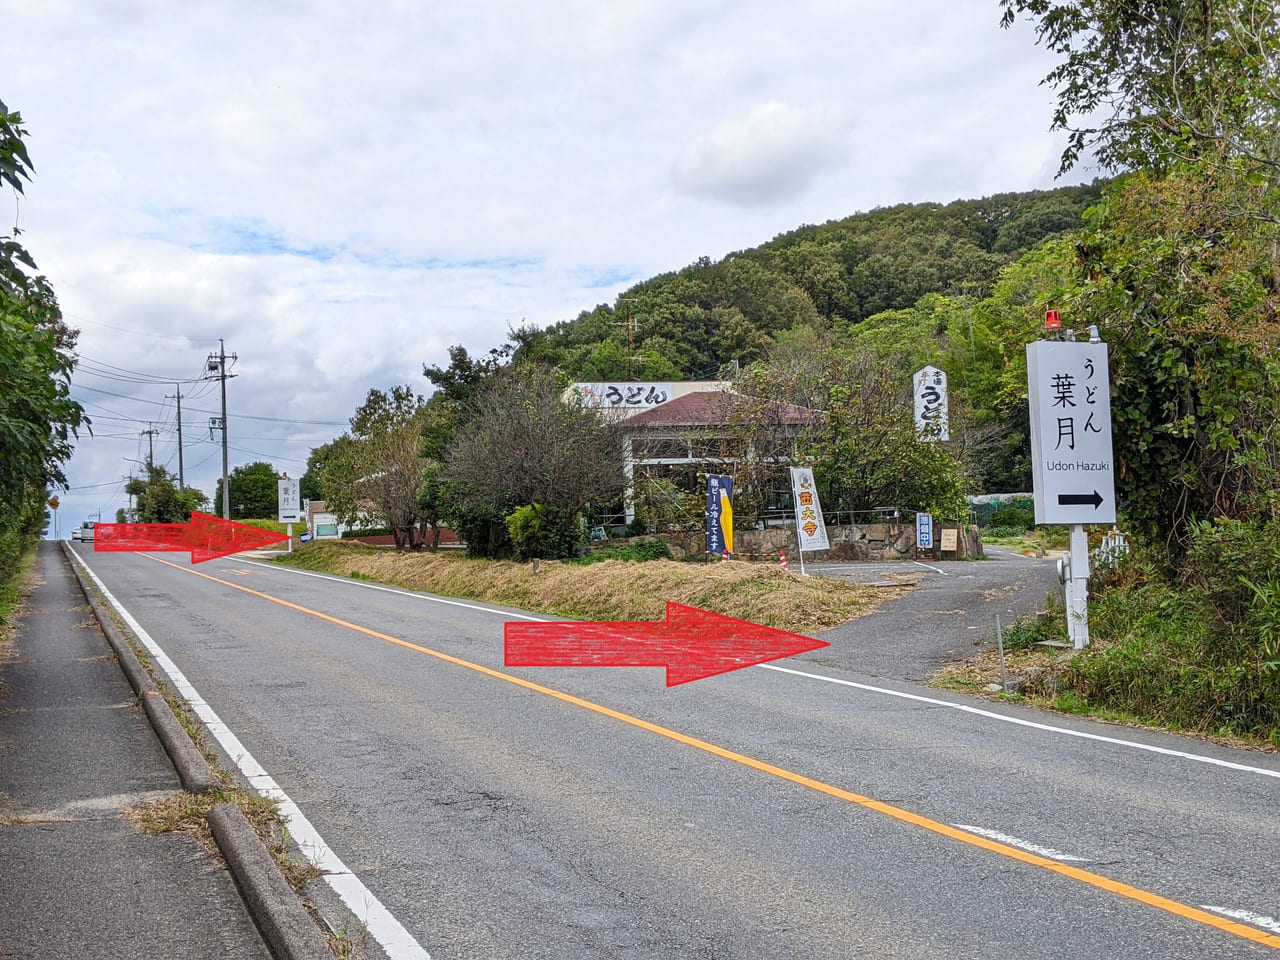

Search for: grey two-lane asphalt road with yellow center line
xmin=70 ymin=548 xmax=1280 ymax=960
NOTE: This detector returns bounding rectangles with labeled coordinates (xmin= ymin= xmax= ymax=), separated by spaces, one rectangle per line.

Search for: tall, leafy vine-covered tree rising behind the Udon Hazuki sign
xmin=1002 ymin=0 xmax=1280 ymax=547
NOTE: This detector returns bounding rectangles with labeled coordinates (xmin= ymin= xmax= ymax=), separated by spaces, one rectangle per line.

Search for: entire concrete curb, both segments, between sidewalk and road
xmin=61 ymin=540 xmax=333 ymax=960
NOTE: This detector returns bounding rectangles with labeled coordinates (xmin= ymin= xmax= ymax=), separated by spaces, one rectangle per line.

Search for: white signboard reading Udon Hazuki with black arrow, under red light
xmin=1027 ymin=340 xmax=1116 ymax=524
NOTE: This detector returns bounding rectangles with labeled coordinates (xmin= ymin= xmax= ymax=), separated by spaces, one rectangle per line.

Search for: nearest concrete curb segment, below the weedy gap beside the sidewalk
xmin=209 ymin=804 xmax=333 ymax=960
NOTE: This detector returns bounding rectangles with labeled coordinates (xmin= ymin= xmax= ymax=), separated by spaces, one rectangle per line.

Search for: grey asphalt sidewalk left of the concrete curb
xmin=0 ymin=543 xmax=271 ymax=960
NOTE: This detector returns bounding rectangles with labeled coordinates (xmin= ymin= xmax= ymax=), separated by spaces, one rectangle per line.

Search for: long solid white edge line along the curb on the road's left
xmin=73 ymin=552 xmax=431 ymax=960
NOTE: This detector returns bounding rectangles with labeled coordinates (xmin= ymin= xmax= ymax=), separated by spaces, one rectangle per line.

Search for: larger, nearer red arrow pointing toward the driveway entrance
xmin=503 ymin=603 xmax=831 ymax=686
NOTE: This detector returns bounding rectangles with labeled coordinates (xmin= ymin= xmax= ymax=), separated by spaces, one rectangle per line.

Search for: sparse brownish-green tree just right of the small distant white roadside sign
xmin=320 ymin=387 xmax=439 ymax=550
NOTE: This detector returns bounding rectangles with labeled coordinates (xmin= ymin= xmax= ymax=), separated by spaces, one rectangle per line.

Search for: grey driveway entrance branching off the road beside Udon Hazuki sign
xmin=803 ymin=547 xmax=1061 ymax=681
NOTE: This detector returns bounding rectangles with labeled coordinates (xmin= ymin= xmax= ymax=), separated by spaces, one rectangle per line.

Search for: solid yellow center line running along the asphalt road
xmin=142 ymin=554 xmax=1280 ymax=950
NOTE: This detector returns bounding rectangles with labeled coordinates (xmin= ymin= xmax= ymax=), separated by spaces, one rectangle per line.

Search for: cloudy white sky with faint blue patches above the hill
xmin=0 ymin=0 xmax=1061 ymax=536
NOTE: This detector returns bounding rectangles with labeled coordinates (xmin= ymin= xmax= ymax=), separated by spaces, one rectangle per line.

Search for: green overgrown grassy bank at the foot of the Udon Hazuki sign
xmin=934 ymin=547 xmax=1280 ymax=748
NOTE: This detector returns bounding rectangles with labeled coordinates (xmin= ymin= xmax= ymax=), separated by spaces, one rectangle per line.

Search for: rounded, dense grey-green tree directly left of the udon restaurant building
xmin=443 ymin=366 xmax=622 ymax=556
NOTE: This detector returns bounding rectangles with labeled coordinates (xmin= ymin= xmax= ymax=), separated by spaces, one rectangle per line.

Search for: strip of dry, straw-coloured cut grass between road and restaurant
xmin=280 ymin=543 xmax=910 ymax=634
